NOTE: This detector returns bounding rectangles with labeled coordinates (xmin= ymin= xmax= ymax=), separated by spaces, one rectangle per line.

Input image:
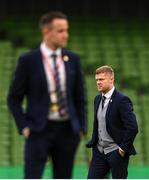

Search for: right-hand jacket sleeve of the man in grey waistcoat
xmin=120 ymin=97 xmax=138 ymax=153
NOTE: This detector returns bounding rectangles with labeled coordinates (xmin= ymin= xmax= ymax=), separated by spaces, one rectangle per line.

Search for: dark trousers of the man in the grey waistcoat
xmin=88 ymin=147 xmax=129 ymax=179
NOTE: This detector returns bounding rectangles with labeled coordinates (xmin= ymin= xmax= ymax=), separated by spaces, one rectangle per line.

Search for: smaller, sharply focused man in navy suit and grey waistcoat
xmin=87 ymin=66 xmax=138 ymax=179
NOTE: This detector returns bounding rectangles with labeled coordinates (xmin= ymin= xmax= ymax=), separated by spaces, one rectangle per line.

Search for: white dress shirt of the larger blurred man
xmin=40 ymin=42 xmax=68 ymax=121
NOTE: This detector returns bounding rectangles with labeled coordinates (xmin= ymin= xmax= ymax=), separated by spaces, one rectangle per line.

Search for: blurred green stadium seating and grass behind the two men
xmin=0 ymin=0 xmax=149 ymax=179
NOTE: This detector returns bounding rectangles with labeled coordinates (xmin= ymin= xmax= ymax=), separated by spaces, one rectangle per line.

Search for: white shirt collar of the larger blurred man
xmin=40 ymin=42 xmax=62 ymax=57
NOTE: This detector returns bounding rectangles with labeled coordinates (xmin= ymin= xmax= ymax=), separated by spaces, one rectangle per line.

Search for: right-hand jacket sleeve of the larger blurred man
xmin=75 ymin=57 xmax=87 ymax=134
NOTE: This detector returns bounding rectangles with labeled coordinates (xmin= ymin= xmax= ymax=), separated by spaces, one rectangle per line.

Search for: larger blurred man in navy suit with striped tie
xmin=8 ymin=12 xmax=86 ymax=179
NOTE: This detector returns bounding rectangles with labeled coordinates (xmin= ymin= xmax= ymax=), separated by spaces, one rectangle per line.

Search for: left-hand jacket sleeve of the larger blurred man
xmin=7 ymin=57 xmax=27 ymax=133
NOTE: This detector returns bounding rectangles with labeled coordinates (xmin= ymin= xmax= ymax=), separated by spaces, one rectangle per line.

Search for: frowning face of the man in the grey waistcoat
xmin=95 ymin=73 xmax=114 ymax=94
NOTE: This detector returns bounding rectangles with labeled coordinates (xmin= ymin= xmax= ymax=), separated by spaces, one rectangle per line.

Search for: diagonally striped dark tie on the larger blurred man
xmin=51 ymin=54 xmax=67 ymax=116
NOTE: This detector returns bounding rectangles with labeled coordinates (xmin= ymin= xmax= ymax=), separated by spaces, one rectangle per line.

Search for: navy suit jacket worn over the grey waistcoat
xmin=87 ymin=90 xmax=138 ymax=155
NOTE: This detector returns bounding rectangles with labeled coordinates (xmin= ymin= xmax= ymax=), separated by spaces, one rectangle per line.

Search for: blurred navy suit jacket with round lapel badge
xmin=8 ymin=49 xmax=87 ymax=133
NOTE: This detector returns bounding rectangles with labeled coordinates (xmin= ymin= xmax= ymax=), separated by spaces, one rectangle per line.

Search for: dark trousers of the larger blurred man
xmin=25 ymin=121 xmax=80 ymax=179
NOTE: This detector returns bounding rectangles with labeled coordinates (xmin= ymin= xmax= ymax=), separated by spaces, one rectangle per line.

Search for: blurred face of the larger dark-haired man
xmin=44 ymin=19 xmax=69 ymax=48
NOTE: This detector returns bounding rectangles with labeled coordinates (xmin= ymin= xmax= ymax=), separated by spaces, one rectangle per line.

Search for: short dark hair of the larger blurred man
xmin=39 ymin=11 xmax=67 ymax=29
